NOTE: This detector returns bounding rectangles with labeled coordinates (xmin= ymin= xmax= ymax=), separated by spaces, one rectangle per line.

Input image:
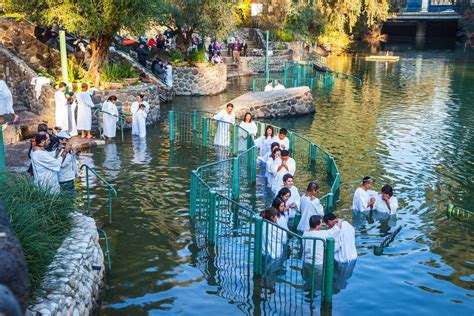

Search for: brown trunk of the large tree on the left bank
xmin=86 ymin=35 xmax=112 ymax=87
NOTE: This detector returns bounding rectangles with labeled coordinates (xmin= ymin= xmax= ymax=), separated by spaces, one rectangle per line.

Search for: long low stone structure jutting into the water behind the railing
xmin=222 ymin=87 xmax=316 ymax=118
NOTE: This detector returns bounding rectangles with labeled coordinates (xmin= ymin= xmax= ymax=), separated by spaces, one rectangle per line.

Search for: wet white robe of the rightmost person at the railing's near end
xmin=330 ymin=221 xmax=357 ymax=262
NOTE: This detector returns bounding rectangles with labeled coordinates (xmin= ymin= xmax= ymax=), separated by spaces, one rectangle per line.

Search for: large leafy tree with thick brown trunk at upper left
xmin=9 ymin=0 xmax=159 ymax=85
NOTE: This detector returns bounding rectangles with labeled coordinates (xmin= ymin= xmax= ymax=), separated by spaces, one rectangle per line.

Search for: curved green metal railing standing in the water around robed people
xmin=169 ymin=111 xmax=340 ymax=303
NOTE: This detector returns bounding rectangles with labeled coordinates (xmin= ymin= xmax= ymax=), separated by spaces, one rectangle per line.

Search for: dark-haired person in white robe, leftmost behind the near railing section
xmin=260 ymin=207 xmax=288 ymax=260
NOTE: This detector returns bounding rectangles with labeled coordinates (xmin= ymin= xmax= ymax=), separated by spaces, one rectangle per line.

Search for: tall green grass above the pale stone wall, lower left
xmin=0 ymin=173 xmax=75 ymax=297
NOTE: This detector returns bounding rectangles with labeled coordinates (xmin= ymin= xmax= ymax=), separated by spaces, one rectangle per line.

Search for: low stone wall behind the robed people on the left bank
xmin=93 ymin=83 xmax=160 ymax=128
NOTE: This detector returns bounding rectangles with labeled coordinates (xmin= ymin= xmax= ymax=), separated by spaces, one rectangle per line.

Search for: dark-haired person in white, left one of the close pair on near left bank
xmin=31 ymin=132 xmax=63 ymax=193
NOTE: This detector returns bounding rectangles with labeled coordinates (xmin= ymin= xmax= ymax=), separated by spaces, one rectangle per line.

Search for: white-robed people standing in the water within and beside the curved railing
xmin=209 ymin=103 xmax=398 ymax=284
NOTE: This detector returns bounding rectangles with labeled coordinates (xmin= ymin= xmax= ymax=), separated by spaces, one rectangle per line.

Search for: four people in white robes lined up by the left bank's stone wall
xmin=55 ymin=82 xmax=150 ymax=139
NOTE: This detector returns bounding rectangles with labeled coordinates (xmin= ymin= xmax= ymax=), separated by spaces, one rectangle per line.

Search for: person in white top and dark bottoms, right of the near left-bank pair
xmin=58 ymin=131 xmax=80 ymax=193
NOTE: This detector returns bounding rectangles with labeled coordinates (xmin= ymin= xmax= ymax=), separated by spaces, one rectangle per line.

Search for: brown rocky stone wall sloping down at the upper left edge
xmin=0 ymin=18 xmax=61 ymax=75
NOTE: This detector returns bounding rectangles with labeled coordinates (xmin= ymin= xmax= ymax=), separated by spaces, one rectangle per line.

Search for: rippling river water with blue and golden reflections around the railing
xmin=82 ymin=51 xmax=474 ymax=315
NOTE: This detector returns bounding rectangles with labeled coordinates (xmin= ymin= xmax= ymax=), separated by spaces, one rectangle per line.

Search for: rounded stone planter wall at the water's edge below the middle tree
xmin=173 ymin=64 xmax=227 ymax=95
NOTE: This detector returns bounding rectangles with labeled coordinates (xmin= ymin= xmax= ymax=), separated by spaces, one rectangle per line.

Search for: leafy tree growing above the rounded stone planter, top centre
xmin=158 ymin=0 xmax=238 ymax=50
